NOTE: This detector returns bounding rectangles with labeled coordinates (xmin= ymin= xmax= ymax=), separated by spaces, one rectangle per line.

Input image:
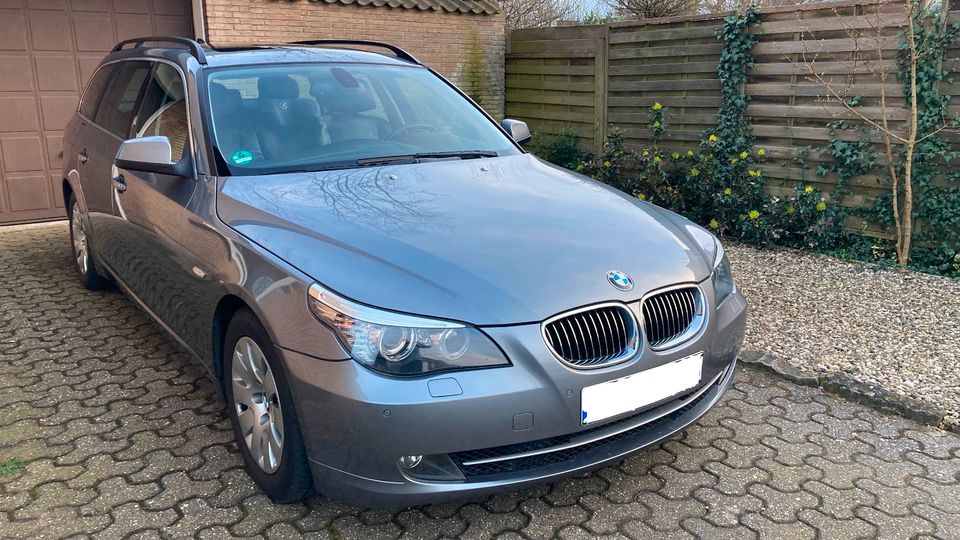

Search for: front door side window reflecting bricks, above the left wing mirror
xmin=133 ymin=64 xmax=189 ymax=162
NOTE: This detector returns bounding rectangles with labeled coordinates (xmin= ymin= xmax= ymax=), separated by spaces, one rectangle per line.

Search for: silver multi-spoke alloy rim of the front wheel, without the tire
xmin=232 ymin=336 xmax=283 ymax=474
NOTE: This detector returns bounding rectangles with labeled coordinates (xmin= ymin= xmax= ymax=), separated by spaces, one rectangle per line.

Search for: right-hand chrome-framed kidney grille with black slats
xmin=642 ymin=287 xmax=703 ymax=349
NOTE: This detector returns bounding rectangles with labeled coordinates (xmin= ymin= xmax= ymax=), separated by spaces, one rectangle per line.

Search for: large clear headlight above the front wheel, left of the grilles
xmin=308 ymin=284 xmax=510 ymax=375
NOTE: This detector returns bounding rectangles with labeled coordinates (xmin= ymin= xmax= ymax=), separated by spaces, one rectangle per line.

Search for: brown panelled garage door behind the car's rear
xmin=0 ymin=0 xmax=193 ymax=224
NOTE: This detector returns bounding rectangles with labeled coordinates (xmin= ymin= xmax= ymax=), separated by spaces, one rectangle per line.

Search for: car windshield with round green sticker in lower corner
xmin=207 ymin=64 xmax=520 ymax=175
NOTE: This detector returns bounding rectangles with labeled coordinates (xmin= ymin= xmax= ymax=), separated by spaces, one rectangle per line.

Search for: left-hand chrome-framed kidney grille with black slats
xmin=543 ymin=305 xmax=637 ymax=368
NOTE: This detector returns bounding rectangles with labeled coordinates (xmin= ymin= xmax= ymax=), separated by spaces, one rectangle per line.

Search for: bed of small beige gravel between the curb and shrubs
xmin=727 ymin=245 xmax=960 ymax=425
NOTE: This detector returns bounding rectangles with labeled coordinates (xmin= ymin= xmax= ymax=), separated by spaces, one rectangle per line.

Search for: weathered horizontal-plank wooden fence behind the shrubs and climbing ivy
xmin=506 ymin=0 xmax=960 ymax=234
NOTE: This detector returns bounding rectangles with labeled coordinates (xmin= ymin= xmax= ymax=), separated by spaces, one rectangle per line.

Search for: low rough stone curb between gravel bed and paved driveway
xmin=740 ymin=350 xmax=960 ymax=433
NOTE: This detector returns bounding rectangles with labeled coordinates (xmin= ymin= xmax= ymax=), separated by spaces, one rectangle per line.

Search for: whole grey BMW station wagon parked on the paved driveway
xmin=63 ymin=37 xmax=747 ymax=507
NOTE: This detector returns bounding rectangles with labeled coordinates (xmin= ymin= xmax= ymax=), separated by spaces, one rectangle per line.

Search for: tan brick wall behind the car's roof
xmin=204 ymin=0 xmax=506 ymax=119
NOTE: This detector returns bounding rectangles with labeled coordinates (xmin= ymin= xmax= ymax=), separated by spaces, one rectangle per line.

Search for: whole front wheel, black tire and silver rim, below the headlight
xmin=222 ymin=308 xmax=313 ymax=503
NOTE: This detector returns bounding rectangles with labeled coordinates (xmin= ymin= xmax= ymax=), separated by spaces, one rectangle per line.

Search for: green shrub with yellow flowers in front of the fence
xmin=576 ymin=103 xmax=844 ymax=248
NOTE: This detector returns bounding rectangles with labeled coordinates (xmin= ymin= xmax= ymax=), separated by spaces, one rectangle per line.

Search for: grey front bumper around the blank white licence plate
xmin=281 ymin=293 xmax=746 ymax=507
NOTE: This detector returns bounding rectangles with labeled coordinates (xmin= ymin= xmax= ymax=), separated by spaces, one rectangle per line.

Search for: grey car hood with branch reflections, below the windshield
xmin=217 ymin=155 xmax=710 ymax=325
